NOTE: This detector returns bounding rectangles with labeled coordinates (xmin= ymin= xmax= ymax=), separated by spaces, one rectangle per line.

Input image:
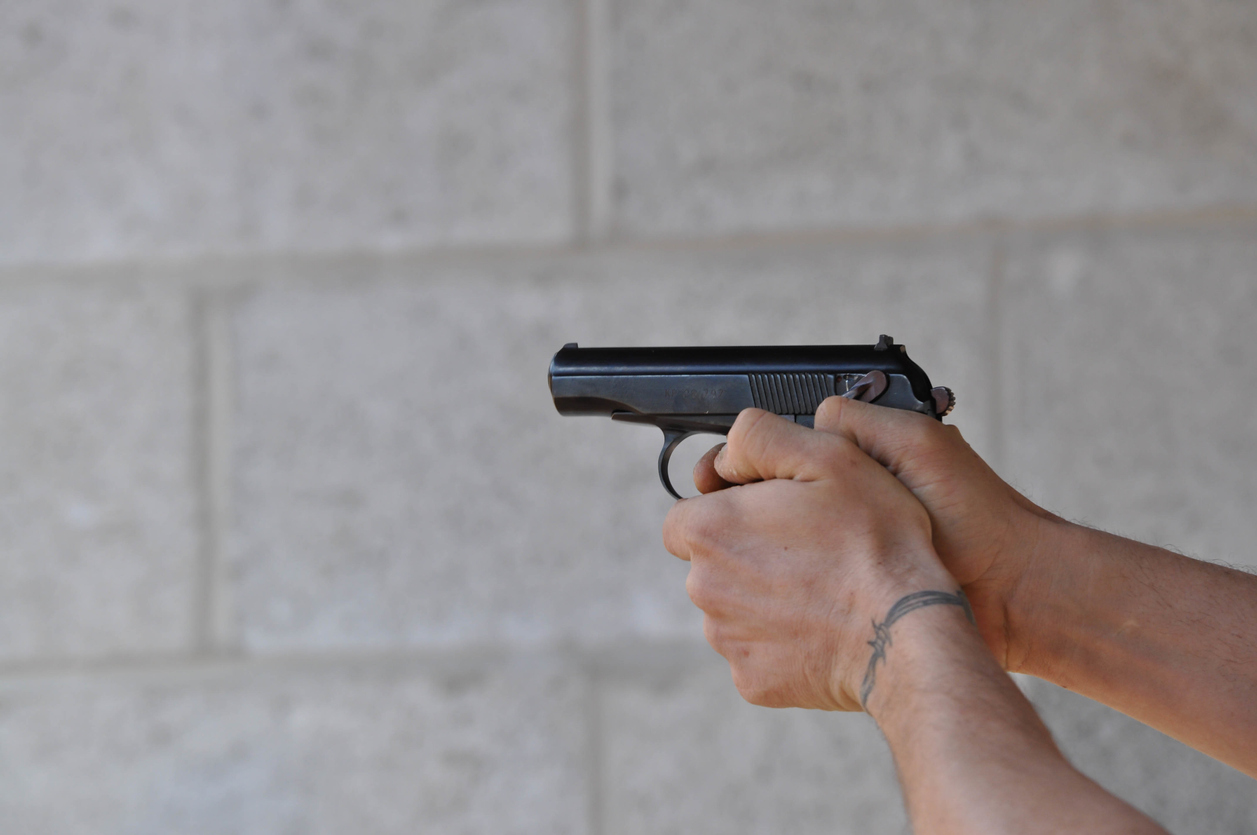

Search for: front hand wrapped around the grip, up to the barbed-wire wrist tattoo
xmin=664 ymin=409 xmax=955 ymax=711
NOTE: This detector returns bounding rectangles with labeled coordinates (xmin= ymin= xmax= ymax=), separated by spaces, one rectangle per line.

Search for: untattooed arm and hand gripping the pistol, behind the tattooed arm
xmin=804 ymin=399 xmax=1257 ymax=777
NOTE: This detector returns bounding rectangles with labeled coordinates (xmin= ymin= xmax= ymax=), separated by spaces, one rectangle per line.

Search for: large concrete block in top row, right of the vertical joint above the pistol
xmin=608 ymin=0 xmax=1257 ymax=236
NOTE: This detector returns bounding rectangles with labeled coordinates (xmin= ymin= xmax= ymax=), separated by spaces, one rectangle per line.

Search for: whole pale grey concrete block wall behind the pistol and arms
xmin=0 ymin=0 xmax=1257 ymax=835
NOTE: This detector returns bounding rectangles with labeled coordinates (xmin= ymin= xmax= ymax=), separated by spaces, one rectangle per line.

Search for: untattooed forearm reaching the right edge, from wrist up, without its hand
xmin=1008 ymin=523 xmax=1257 ymax=777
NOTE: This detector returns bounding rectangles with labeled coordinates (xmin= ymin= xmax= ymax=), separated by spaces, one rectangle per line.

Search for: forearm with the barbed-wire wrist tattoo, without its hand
xmin=866 ymin=606 xmax=1164 ymax=835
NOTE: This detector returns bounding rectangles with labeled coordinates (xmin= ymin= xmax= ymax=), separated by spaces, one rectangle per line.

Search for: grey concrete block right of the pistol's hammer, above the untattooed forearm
xmin=1003 ymin=226 xmax=1257 ymax=566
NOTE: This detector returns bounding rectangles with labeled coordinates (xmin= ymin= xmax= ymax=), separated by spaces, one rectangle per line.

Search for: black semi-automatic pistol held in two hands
xmin=549 ymin=335 xmax=955 ymax=499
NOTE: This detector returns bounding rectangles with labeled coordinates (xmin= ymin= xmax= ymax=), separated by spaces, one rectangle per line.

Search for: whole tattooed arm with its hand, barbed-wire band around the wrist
xmin=664 ymin=410 xmax=1163 ymax=835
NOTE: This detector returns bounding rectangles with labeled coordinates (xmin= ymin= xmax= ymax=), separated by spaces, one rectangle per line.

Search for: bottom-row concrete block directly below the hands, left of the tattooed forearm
xmin=600 ymin=654 xmax=908 ymax=835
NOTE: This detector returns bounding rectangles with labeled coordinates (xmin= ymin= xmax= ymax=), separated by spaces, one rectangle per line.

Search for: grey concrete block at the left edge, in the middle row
xmin=0 ymin=284 xmax=199 ymax=660
